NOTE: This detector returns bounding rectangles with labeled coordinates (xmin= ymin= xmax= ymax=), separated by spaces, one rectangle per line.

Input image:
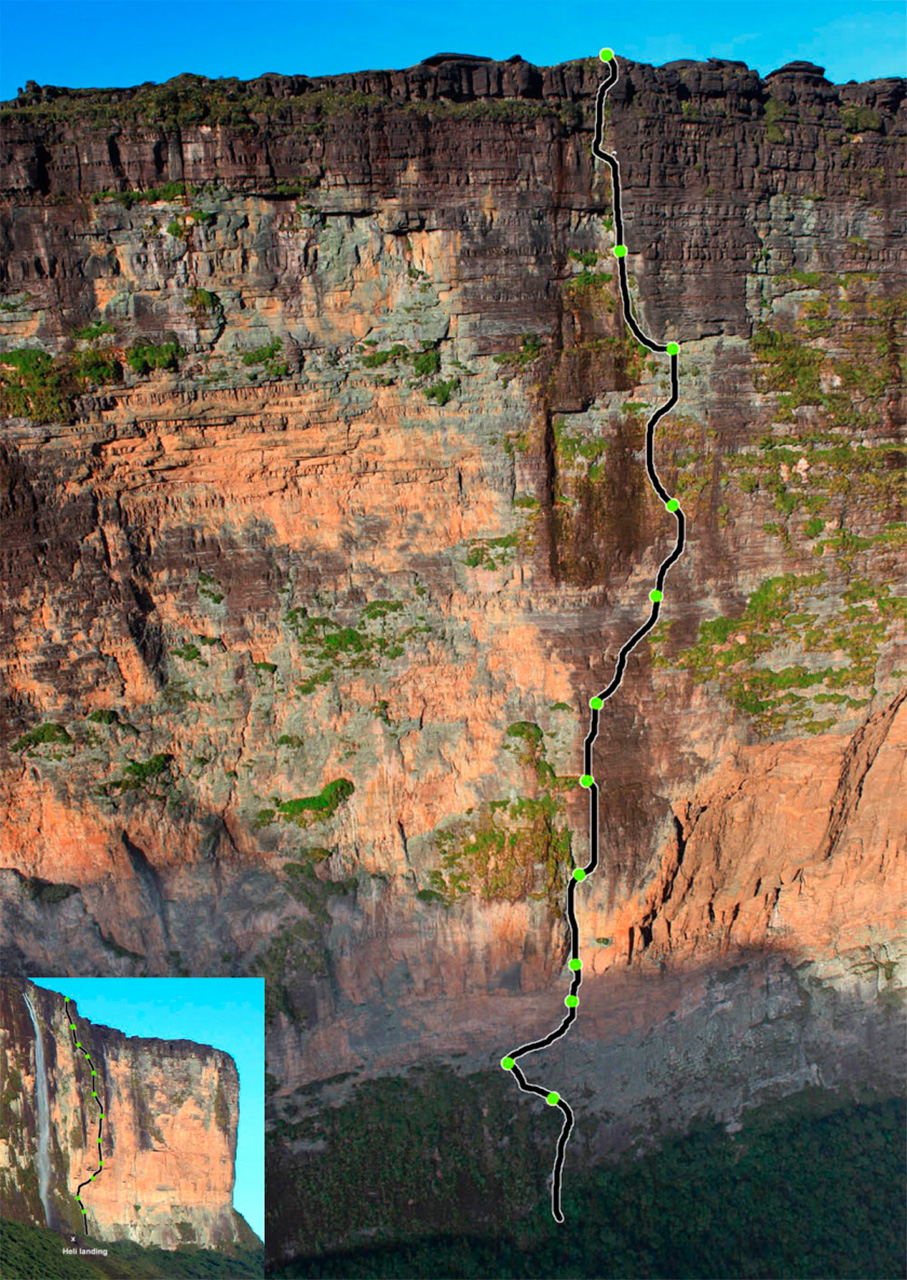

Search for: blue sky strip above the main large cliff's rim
xmin=0 ymin=0 xmax=907 ymax=99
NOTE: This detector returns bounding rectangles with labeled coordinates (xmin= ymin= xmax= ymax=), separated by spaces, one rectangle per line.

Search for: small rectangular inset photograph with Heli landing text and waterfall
xmin=0 ymin=977 xmax=265 ymax=1280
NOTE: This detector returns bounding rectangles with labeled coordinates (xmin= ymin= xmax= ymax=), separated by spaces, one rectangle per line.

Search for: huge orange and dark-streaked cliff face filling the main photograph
xmin=0 ymin=52 xmax=907 ymax=1252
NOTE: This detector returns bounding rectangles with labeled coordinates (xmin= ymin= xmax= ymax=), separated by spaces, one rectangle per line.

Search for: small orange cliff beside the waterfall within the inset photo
xmin=0 ymin=978 xmax=248 ymax=1249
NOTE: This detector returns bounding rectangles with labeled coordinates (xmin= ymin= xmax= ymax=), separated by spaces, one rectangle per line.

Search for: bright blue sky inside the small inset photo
xmin=32 ymin=978 xmax=265 ymax=1238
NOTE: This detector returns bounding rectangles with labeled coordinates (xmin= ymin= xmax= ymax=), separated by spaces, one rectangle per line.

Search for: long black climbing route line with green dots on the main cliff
xmin=501 ymin=49 xmax=686 ymax=1222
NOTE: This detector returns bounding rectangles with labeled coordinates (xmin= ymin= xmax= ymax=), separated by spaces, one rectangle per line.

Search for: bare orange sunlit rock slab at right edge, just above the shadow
xmin=586 ymin=695 xmax=907 ymax=969
